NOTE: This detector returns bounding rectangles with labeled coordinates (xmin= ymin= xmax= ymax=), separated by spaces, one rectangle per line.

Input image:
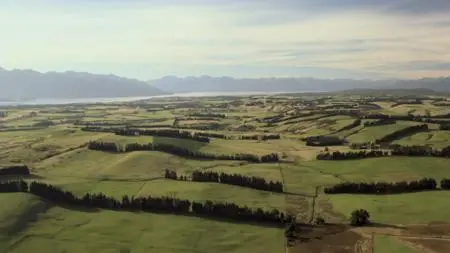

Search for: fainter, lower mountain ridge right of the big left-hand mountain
xmin=148 ymin=76 xmax=450 ymax=92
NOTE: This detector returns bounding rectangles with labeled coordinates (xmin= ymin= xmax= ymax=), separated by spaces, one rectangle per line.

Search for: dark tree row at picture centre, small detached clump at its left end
xmin=165 ymin=169 xmax=283 ymax=193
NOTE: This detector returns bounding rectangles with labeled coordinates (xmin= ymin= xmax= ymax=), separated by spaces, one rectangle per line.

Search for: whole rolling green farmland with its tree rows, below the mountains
xmin=0 ymin=93 xmax=450 ymax=253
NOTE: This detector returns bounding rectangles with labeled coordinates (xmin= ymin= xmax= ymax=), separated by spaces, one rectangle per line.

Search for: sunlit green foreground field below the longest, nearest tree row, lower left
xmin=4 ymin=201 xmax=284 ymax=253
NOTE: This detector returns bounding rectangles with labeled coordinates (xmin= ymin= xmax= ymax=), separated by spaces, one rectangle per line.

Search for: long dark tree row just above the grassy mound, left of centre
xmin=88 ymin=141 xmax=280 ymax=163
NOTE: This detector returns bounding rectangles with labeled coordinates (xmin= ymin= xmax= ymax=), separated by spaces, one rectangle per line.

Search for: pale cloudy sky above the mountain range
xmin=0 ymin=0 xmax=450 ymax=80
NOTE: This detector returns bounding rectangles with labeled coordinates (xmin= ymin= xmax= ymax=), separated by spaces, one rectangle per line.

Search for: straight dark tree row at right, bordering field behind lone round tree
xmin=324 ymin=178 xmax=437 ymax=194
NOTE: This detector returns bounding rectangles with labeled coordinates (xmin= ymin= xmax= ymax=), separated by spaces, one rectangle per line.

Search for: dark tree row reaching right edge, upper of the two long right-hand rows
xmin=316 ymin=145 xmax=450 ymax=160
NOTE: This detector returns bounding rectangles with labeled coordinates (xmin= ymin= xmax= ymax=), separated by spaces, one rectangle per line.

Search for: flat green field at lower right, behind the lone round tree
xmin=328 ymin=191 xmax=450 ymax=224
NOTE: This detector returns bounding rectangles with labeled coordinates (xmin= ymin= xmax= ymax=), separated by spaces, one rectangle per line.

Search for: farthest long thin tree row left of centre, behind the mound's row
xmin=81 ymin=127 xmax=281 ymax=143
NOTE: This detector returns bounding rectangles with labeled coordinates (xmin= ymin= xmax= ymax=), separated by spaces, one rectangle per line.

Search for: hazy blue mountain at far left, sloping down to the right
xmin=0 ymin=68 xmax=166 ymax=101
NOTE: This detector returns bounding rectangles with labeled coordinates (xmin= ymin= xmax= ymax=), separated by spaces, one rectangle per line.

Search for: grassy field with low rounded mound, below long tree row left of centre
xmin=35 ymin=149 xmax=244 ymax=179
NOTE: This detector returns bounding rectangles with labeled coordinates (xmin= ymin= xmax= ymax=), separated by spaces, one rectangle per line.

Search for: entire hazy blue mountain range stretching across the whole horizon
xmin=0 ymin=68 xmax=450 ymax=101
